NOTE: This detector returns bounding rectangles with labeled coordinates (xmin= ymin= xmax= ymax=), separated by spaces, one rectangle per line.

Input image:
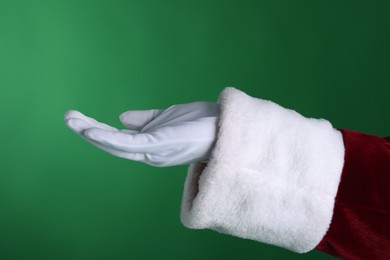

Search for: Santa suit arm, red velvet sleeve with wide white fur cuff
xmin=181 ymin=88 xmax=389 ymax=258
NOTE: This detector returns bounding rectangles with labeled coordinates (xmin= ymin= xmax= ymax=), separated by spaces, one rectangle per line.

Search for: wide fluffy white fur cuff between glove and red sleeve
xmin=181 ymin=88 xmax=344 ymax=253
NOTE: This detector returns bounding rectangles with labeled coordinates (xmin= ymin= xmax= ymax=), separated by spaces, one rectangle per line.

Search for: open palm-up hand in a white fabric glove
xmin=65 ymin=102 xmax=219 ymax=166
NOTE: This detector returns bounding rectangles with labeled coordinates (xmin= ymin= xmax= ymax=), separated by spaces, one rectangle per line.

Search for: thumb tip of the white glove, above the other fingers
xmin=119 ymin=109 xmax=163 ymax=130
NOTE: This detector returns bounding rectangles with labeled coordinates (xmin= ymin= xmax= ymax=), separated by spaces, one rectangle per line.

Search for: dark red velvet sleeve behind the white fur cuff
xmin=316 ymin=130 xmax=390 ymax=259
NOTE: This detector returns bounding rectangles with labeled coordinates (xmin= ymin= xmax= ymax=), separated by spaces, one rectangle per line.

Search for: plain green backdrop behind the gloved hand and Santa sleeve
xmin=0 ymin=0 xmax=390 ymax=260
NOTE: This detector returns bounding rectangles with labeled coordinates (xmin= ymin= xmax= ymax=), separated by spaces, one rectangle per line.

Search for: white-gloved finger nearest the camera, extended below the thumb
xmin=83 ymin=128 xmax=156 ymax=153
